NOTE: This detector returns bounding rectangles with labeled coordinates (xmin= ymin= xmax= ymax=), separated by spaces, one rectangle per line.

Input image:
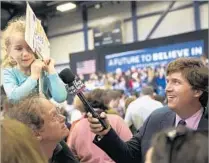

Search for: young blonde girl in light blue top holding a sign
xmin=2 ymin=17 xmax=67 ymax=103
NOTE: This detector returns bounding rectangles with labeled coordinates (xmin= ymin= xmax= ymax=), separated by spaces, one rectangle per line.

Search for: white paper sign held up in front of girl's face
xmin=25 ymin=3 xmax=50 ymax=59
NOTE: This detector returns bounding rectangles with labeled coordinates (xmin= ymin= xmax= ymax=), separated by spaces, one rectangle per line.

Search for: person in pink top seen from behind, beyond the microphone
xmin=67 ymin=89 xmax=132 ymax=163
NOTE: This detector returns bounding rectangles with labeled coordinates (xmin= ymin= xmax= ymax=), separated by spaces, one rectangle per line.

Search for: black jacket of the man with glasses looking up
xmin=49 ymin=141 xmax=79 ymax=163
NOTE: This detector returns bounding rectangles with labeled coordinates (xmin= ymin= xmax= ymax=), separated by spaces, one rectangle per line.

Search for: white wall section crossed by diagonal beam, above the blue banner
xmin=137 ymin=2 xmax=195 ymax=41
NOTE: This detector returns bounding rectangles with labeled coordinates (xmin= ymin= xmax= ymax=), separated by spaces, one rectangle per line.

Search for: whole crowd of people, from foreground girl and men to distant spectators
xmin=0 ymin=15 xmax=208 ymax=163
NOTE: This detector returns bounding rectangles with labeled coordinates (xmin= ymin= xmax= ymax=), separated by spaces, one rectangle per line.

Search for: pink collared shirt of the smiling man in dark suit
xmin=175 ymin=109 xmax=203 ymax=130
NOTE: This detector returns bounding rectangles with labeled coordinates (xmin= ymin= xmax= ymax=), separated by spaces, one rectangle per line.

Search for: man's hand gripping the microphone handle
xmin=87 ymin=112 xmax=111 ymax=136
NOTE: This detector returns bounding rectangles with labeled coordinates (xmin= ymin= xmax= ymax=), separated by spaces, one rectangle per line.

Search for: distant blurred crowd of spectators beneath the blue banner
xmin=79 ymin=65 xmax=166 ymax=96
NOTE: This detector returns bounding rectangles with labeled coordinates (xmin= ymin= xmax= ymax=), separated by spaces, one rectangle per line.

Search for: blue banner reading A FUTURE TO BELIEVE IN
xmin=105 ymin=40 xmax=204 ymax=72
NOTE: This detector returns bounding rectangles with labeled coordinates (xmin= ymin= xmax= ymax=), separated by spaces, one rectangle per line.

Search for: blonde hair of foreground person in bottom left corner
xmin=1 ymin=118 xmax=47 ymax=163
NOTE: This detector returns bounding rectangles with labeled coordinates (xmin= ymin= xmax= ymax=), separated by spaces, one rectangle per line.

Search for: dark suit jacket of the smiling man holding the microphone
xmin=94 ymin=107 xmax=208 ymax=163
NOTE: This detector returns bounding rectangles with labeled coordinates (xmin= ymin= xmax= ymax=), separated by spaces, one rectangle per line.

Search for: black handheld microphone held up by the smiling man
xmin=59 ymin=68 xmax=108 ymax=130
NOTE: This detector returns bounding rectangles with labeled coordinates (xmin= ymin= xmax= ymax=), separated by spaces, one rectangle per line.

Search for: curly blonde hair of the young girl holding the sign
xmin=1 ymin=17 xmax=25 ymax=68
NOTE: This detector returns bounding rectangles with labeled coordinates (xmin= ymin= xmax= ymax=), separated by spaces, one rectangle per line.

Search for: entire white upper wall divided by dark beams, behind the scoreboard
xmin=48 ymin=1 xmax=208 ymax=63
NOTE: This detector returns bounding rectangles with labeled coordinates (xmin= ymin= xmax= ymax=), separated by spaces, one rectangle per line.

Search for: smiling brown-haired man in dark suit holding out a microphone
xmin=88 ymin=58 xmax=208 ymax=163
